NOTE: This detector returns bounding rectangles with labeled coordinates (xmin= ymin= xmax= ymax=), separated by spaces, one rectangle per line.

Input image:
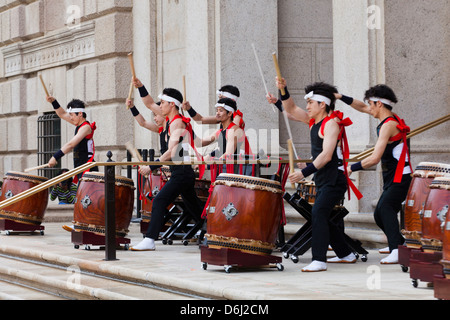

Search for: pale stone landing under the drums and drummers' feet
xmin=0 ymin=222 xmax=436 ymax=301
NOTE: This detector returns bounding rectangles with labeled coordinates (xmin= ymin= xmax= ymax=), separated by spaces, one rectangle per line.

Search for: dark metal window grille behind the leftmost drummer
xmin=38 ymin=112 xmax=61 ymax=179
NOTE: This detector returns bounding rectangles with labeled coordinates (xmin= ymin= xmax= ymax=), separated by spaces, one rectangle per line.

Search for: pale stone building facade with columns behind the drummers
xmin=0 ymin=0 xmax=450 ymax=213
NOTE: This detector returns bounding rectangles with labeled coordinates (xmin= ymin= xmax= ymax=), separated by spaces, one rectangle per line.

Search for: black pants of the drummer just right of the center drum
xmin=311 ymin=174 xmax=352 ymax=262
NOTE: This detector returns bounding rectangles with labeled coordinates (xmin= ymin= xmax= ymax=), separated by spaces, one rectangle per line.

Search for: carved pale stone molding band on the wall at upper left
xmin=2 ymin=22 xmax=95 ymax=77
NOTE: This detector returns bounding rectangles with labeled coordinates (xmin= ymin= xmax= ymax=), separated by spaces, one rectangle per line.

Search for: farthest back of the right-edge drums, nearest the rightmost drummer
xmin=402 ymin=162 xmax=450 ymax=248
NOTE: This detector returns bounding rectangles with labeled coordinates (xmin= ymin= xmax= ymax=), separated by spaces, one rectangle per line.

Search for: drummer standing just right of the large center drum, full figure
xmin=277 ymin=79 xmax=356 ymax=272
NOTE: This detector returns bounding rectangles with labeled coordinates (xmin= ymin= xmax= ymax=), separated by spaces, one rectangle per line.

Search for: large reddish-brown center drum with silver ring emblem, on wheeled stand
xmin=205 ymin=174 xmax=283 ymax=255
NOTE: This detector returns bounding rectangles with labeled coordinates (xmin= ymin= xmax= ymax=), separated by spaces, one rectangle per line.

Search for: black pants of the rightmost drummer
xmin=374 ymin=174 xmax=412 ymax=251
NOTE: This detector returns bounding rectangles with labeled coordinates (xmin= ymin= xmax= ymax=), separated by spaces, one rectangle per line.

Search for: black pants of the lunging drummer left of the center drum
xmin=145 ymin=166 xmax=203 ymax=240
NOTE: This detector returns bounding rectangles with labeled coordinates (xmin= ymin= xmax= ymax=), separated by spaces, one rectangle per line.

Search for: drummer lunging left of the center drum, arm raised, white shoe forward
xmin=131 ymin=79 xmax=203 ymax=251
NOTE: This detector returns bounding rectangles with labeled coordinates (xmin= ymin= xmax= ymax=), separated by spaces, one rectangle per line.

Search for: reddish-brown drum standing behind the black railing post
xmin=74 ymin=172 xmax=135 ymax=238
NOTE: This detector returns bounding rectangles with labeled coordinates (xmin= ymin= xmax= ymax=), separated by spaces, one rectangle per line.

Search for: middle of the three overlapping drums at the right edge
xmin=421 ymin=176 xmax=450 ymax=252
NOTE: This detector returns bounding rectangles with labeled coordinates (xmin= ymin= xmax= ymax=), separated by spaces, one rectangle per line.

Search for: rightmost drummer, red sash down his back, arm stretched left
xmin=336 ymin=85 xmax=413 ymax=264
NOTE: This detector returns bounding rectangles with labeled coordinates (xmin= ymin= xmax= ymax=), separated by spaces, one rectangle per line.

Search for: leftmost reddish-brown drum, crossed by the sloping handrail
xmin=0 ymin=172 xmax=48 ymax=226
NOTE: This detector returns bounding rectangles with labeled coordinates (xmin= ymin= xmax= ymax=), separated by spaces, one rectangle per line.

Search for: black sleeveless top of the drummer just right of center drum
xmin=311 ymin=119 xmax=342 ymax=188
